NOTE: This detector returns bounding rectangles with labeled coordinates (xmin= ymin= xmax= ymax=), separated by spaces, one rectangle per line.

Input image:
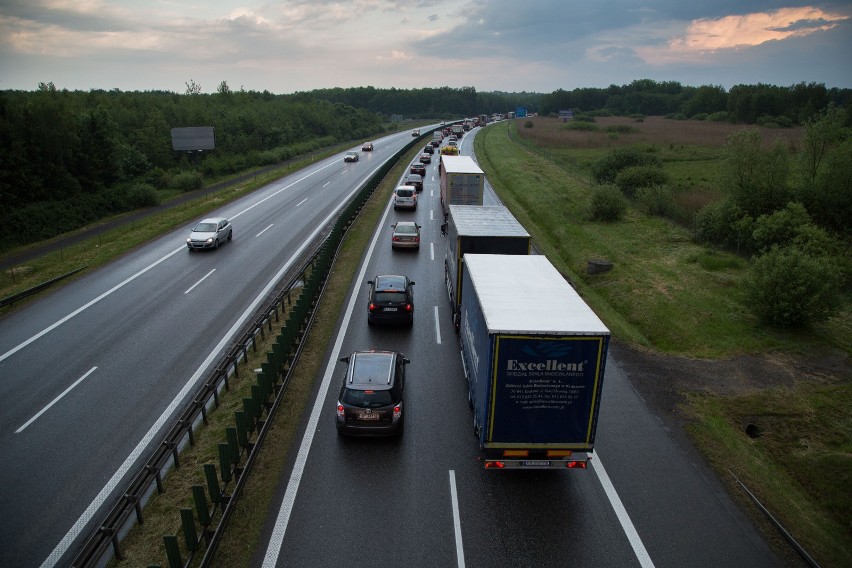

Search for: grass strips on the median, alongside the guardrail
xmin=110 ymin=143 xmax=419 ymax=568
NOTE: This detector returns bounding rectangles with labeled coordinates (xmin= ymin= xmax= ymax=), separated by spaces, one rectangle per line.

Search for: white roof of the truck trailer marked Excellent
xmin=464 ymin=254 xmax=609 ymax=335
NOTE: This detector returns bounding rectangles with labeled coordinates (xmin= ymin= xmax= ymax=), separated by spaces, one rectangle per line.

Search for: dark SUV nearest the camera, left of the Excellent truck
xmin=337 ymin=351 xmax=411 ymax=436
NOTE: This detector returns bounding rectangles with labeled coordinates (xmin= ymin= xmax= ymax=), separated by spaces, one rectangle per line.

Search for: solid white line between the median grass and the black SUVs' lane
xmin=262 ymin=186 xmax=391 ymax=568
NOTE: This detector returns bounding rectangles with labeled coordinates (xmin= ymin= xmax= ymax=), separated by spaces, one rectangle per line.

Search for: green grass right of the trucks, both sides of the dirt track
xmin=476 ymin=123 xmax=852 ymax=567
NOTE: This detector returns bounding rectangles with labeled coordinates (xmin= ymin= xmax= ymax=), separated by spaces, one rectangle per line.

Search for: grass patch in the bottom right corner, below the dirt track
xmin=686 ymin=381 xmax=852 ymax=568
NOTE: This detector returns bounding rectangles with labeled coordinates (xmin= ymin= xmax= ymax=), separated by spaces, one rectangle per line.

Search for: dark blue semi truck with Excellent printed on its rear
xmin=459 ymin=254 xmax=610 ymax=469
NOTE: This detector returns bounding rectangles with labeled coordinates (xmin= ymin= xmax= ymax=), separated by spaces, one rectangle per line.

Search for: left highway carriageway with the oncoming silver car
xmin=0 ymin=132 xmax=411 ymax=567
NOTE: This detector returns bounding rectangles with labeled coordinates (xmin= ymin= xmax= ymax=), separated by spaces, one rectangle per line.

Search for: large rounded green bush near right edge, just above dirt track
xmin=745 ymin=247 xmax=843 ymax=327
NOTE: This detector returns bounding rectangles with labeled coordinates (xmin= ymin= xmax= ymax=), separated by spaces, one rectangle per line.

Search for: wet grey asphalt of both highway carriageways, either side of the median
xmin=0 ymin=125 xmax=781 ymax=567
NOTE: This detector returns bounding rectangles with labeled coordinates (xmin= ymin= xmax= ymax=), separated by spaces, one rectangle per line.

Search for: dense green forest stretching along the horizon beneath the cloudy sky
xmin=0 ymin=79 xmax=852 ymax=249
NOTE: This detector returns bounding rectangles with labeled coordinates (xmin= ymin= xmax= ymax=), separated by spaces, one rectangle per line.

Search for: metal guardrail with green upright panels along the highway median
xmin=71 ymin=131 xmax=430 ymax=568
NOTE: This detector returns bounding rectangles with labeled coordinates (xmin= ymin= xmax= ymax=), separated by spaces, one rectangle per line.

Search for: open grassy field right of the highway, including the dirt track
xmin=476 ymin=118 xmax=852 ymax=567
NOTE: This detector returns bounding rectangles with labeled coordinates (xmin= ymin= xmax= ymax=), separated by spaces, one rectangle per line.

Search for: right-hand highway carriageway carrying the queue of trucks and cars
xmin=252 ymin=130 xmax=780 ymax=568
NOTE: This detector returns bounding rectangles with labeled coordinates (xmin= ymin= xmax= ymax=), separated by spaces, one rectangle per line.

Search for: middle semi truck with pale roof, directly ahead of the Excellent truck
xmin=444 ymin=205 xmax=532 ymax=331
